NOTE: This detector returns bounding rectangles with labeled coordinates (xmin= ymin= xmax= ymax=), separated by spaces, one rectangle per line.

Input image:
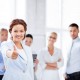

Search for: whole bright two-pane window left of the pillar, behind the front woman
xmin=0 ymin=0 xmax=27 ymax=29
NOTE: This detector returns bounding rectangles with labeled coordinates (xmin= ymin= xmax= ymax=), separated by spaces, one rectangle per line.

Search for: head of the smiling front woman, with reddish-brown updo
xmin=9 ymin=19 xmax=27 ymax=41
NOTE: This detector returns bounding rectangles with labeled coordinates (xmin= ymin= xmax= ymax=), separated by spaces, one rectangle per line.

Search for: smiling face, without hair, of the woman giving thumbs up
xmin=11 ymin=24 xmax=25 ymax=42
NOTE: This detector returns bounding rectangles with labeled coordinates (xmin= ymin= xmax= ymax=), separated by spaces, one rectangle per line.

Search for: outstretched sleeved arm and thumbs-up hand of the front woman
xmin=1 ymin=42 xmax=18 ymax=59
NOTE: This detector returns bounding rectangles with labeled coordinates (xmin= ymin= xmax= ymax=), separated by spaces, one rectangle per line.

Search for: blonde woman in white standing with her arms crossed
xmin=36 ymin=32 xmax=63 ymax=80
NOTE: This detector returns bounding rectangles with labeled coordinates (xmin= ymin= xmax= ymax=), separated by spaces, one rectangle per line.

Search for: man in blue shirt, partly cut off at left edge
xmin=0 ymin=28 xmax=8 ymax=80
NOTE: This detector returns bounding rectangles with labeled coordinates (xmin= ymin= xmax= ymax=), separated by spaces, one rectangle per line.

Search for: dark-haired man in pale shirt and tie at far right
xmin=65 ymin=23 xmax=80 ymax=80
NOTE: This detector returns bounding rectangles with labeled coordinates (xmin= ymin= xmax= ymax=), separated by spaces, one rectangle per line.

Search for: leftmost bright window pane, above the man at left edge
xmin=0 ymin=0 xmax=15 ymax=28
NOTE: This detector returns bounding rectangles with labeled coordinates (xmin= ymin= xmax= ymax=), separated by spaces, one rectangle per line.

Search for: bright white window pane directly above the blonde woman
xmin=46 ymin=0 xmax=61 ymax=28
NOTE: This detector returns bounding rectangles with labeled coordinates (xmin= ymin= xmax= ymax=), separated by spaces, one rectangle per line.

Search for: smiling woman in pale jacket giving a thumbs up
xmin=1 ymin=19 xmax=34 ymax=80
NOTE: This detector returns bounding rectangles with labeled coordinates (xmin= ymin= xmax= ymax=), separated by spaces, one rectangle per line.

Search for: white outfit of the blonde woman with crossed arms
xmin=36 ymin=47 xmax=63 ymax=80
